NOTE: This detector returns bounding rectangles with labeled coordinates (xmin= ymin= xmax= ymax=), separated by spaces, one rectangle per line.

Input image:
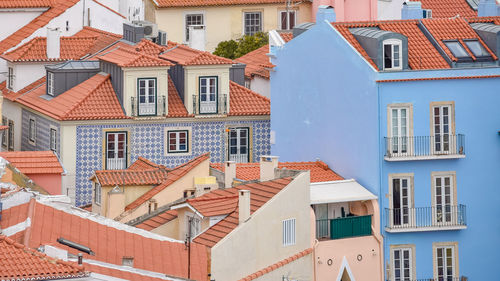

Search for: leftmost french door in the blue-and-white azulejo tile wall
xmin=106 ymin=132 xmax=127 ymax=170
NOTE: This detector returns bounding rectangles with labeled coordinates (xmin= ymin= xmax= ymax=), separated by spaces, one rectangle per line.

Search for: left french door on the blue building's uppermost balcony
xmin=391 ymin=108 xmax=410 ymax=155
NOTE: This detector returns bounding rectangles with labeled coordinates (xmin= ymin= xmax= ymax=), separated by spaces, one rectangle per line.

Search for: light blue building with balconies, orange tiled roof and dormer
xmin=271 ymin=8 xmax=500 ymax=281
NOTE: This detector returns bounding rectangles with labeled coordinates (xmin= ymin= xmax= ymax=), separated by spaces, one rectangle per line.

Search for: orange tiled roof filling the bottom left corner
xmin=0 ymin=235 xmax=87 ymax=281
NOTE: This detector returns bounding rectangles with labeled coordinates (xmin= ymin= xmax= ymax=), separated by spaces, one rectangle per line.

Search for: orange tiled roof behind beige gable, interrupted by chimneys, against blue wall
xmin=210 ymin=160 xmax=344 ymax=182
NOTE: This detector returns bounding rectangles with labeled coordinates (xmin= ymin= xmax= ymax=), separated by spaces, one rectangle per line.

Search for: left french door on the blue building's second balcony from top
xmin=392 ymin=178 xmax=413 ymax=226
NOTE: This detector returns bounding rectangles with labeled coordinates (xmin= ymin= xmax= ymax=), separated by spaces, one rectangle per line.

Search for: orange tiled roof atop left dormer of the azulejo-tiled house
xmin=97 ymin=47 xmax=173 ymax=67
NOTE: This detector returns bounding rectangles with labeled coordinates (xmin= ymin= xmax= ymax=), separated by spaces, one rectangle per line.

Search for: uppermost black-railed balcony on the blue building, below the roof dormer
xmin=384 ymin=134 xmax=465 ymax=161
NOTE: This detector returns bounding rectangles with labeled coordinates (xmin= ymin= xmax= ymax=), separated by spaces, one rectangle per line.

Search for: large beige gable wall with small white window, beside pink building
xmin=211 ymin=172 xmax=313 ymax=281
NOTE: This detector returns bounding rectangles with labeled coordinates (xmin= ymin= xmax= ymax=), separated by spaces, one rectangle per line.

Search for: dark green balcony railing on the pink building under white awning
xmin=316 ymin=215 xmax=372 ymax=239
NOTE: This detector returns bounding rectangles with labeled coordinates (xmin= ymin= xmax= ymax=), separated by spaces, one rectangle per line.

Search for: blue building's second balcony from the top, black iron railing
xmin=385 ymin=205 xmax=467 ymax=232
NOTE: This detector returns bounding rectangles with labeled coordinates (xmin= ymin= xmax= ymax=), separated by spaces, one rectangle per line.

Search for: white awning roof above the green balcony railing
xmin=311 ymin=179 xmax=377 ymax=205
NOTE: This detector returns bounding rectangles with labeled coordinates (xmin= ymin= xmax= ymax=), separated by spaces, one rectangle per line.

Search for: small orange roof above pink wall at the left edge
xmin=0 ymin=151 xmax=64 ymax=175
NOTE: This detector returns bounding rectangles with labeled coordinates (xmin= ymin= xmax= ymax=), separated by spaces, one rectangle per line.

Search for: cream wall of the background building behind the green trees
xmin=150 ymin=0 xmax=312 ymax=52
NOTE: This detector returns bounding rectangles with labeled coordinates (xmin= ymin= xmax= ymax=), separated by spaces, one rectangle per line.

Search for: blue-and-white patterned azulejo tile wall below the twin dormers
xmin=75 ymin=120 xmax=271 ymax=206
